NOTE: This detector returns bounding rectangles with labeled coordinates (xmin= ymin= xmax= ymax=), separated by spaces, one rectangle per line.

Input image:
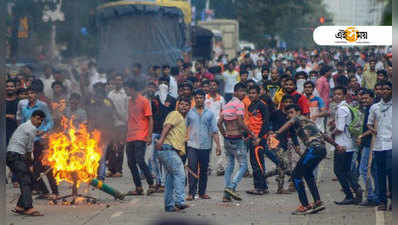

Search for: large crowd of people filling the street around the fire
xmin=5 ymin=47 xmax=392 ymax=216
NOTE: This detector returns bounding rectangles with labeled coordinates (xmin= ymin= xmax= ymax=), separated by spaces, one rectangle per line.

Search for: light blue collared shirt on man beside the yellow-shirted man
xmin=186 ymin=107 xmax=218 ymax=149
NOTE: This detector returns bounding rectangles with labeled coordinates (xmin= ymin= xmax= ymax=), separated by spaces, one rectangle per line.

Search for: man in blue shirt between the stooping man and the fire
xmin=17 ymin=88 xmax=58 ymax=198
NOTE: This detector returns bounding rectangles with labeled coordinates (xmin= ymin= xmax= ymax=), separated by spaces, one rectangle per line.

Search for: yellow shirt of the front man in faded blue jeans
xmin=164 ymin=111 xmax=187 ymax=155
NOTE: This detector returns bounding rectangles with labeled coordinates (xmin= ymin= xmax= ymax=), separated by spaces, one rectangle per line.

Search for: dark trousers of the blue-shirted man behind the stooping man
xmin=33 ymin=141 xmax=59 ymax=195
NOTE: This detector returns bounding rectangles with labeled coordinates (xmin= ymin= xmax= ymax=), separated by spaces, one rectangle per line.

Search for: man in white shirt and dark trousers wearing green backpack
xmin=332 ymin=87 xmax=362 ymax=205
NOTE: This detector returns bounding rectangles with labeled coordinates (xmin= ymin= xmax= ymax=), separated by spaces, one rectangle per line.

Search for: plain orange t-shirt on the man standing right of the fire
xmin=127 ymin=94 xmax=152 ymax=142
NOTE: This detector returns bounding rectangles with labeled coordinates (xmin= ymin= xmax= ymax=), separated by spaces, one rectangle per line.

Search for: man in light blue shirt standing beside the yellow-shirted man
xmin=186 ymin=90 xmax=221 ymax=201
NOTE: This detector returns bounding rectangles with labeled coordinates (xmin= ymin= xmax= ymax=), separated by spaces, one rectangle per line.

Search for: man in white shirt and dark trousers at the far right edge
xmin=368 ymin=81 xmax=393 ymax=211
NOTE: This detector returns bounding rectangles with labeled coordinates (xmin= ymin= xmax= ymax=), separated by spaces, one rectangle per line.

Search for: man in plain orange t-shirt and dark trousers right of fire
xmin=126 ymin=80 xmax=156 ymax=195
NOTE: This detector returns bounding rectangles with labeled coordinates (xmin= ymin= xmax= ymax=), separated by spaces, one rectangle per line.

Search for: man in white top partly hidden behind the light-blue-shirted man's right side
xmin=205 ymin=80 xmax=225 ymax=176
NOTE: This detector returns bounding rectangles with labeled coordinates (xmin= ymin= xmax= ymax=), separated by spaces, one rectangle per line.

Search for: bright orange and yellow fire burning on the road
xmin=43 ymin=117 xmax=102 ymax=187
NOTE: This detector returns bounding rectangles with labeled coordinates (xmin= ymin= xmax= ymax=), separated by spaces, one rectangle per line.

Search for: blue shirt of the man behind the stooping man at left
xmin=17 ymin=99 xmax=54 ymax=141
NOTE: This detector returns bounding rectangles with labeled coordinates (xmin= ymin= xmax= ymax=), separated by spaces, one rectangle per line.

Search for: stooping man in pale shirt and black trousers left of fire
xmin=6 ymin=110 xmax=46 ymax=216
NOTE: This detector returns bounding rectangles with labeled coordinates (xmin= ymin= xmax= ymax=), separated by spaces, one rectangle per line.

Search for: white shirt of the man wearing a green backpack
xmin=335 ymin=101 xmax=355 ymax=152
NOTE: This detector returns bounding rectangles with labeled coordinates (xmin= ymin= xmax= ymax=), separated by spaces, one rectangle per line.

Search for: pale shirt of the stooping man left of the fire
xmin=7 ymin=120 xmax=37 ymax=155
